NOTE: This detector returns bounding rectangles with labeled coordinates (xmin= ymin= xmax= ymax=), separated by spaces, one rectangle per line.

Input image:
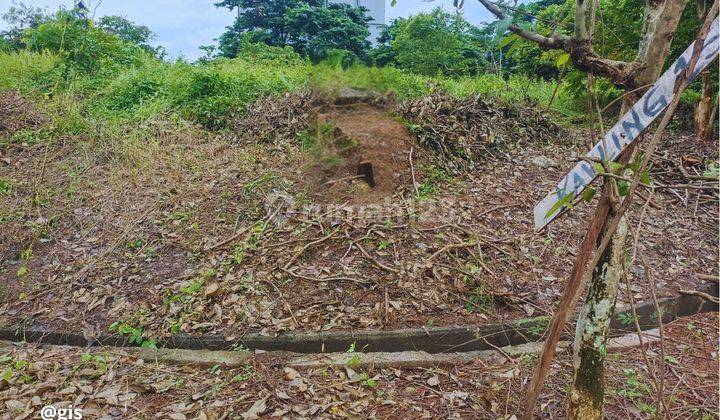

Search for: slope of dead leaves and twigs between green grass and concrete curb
xmin=0 ymin=101 xmax=718 ymax=339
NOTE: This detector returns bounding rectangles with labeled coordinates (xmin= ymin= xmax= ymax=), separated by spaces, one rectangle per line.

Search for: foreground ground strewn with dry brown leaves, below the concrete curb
xmin=0 ymin=313 xmax=719 ymax=420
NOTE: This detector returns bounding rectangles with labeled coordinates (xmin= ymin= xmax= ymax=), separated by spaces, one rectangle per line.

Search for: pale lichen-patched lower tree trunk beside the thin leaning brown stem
xmin=568 ymin=218 xmax=627 ymax=420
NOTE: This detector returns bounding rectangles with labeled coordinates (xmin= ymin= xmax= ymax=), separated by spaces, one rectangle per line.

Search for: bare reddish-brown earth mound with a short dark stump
xmin=306 ymin=104 xmax=413 ymax=202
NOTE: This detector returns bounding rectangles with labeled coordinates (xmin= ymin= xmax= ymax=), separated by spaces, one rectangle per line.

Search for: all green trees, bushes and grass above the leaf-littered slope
xmin=0 ymin=0 xmax=717 ymax=139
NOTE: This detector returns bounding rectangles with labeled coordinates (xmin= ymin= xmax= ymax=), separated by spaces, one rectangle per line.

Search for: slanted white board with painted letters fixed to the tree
xmin=534 ymin=18 xmax=720 ymax=229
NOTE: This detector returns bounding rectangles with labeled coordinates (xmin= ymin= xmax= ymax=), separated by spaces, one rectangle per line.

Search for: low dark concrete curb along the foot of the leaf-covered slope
xmin=0 ymin=283 xmax=718 ymax=354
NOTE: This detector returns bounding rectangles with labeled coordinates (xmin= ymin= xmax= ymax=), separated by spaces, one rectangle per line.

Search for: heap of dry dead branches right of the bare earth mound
xmin=396 ymin=93 xmax=561 ymax=169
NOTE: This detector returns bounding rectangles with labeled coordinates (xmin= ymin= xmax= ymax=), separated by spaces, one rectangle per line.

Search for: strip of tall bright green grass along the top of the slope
xmin=0 ymin=51 xmax=578 ymax=151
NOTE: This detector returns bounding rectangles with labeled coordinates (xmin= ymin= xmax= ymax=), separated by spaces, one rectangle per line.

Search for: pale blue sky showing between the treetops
xmin=0 ymin=0 xmax=493 ymax=60
